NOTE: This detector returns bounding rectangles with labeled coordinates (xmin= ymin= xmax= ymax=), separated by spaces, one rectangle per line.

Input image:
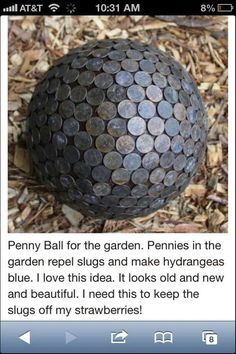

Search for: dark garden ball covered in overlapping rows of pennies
xmin=27 ymin=40 xmax=207 ymax=219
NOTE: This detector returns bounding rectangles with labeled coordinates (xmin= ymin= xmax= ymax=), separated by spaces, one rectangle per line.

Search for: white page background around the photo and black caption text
xmin=1 ymin=17 xmax=235 ymax=320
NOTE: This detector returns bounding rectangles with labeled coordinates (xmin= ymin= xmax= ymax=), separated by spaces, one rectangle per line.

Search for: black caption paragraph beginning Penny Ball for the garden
xmin=5 ymin=237 xmax=225 ymax=319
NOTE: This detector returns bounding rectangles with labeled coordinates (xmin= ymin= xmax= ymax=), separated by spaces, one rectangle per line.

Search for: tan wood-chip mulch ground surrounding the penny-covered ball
xmin=8 ymin=16 xmax=228 ymax=233
